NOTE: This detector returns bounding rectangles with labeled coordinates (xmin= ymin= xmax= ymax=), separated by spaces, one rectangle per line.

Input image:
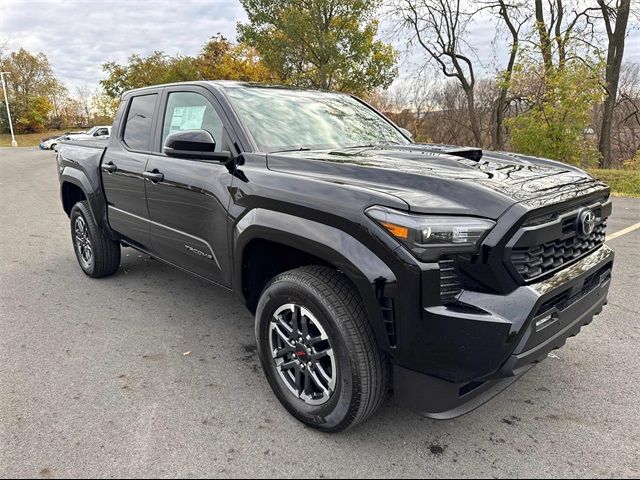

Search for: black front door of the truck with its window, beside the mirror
xmin=146 ymin=86 xmax=238 ymax=286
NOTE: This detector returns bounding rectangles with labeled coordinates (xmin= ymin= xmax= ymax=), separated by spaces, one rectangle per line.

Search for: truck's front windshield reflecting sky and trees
xmin=225 ymin=87 xmax=409 ymax=153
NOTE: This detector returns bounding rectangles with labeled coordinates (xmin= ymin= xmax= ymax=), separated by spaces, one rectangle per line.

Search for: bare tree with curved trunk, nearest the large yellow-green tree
xmin=392 ymin=0 xmax=482 ymax=146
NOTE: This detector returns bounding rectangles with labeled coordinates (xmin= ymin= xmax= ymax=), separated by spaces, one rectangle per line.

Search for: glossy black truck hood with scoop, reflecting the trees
xmin=267 ymin=144 xmax=607 ymax=219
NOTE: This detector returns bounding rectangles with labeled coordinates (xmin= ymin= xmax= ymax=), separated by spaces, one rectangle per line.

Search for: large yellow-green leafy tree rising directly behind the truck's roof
xmin=238 ymin=0 xmax=397 ymax=94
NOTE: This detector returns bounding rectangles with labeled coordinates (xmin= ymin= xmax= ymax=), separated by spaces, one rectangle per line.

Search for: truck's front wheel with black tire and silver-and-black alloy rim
xmin=256 ymin=266 xmax=389 ymax=432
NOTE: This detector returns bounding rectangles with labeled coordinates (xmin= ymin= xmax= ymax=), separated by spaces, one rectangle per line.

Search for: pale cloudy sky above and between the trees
xmin=0 ymin=0 xmax=640 ymax=93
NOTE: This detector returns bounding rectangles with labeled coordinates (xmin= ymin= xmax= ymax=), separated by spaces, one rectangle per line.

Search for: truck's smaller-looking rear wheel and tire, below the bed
xmin=70 ymin=200 xmax=120 ymax=278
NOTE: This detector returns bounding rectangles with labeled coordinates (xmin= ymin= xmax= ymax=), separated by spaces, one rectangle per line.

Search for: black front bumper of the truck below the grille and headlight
xmin=394 ymin=245 xmax=614 ymax=418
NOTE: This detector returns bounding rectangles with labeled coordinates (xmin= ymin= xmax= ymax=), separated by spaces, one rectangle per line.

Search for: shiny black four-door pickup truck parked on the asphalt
xmin=57 ymin=82 xmax=613 ymax=432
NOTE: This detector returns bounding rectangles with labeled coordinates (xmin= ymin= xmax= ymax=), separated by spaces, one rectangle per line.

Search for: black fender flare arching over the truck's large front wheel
xmin=233 ymin=208 xmax=397 ymax=351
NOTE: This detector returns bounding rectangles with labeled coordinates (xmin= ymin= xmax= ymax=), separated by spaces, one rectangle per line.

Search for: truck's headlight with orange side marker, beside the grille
xmin=366 ymin=206 xmax=495 ymax=261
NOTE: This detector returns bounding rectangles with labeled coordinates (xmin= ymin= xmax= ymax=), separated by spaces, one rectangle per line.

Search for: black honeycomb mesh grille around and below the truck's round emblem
xmin=511 ymin=222 xmax=607 ymax=281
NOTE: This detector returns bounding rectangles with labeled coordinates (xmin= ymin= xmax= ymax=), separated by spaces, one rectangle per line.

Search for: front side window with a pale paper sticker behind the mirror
xmin=162 ymin=92 xmax=223 ymax=152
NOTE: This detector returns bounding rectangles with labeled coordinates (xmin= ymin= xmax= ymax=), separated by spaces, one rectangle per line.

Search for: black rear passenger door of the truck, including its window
xmin=101 ymin=91 xmax=160 ymax=250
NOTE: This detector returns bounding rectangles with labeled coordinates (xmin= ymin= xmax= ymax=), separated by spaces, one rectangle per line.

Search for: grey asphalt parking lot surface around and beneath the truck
xmin=0 ymin=149 xmax=640 ymax=478
